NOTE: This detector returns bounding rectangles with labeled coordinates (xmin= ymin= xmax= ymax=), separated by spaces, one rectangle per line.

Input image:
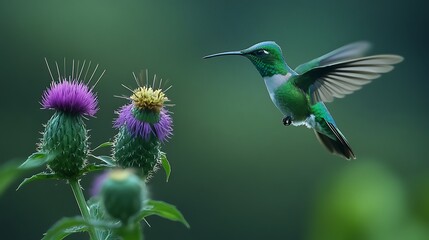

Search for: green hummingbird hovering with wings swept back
xmin=203 ymin=41 xmax=403 ymax=160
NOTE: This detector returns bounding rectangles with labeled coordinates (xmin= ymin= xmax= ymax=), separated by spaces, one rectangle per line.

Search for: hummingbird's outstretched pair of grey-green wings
xmin=293 ymin=43 xmax=403 ymax=103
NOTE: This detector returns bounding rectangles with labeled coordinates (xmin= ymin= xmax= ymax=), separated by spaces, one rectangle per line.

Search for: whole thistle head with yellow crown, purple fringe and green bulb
xmin=113 ymin=71 xmax=173 ymax=180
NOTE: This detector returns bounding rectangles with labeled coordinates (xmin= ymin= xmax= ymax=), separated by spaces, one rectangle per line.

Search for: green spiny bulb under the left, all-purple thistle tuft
xmin=40 ymin=111 xmax=89 ymax=179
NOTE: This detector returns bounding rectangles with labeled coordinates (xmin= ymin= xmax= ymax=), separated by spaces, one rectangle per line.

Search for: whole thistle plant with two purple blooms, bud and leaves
xmin=2 ymin=59 xmax=189 ymax=239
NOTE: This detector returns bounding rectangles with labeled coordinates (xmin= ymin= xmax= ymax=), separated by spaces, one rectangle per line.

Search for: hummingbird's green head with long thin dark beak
xmin=204 ymin=41 xmax=288 ymax=77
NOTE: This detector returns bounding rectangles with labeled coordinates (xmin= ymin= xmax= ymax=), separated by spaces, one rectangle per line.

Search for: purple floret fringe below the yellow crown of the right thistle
xmin=114 ymin=103 xmax=173 ymax=142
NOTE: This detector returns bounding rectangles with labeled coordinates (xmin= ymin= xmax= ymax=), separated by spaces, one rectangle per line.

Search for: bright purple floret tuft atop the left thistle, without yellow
xmin=42 ymin=79 xmax=98 ymax=117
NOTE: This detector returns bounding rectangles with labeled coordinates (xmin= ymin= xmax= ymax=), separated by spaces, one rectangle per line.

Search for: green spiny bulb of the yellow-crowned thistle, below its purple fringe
xmin=113 ymin=126 xmax=161 ymax=178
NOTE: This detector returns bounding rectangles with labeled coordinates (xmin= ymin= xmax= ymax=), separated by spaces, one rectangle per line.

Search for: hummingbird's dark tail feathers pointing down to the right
xmin=314 ymin=120 xmax=356 ymax=160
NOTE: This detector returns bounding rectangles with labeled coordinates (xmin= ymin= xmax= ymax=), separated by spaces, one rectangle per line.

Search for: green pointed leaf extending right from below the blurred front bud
xmin=137 ymin=200 xmax=190 ymax=228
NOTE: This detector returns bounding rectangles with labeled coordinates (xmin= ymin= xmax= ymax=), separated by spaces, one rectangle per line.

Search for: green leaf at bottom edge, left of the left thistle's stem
xmin=42 ymin=217 xmax=88 ymax=240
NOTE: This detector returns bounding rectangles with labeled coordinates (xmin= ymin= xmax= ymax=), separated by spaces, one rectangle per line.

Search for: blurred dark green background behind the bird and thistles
xmin=0 ymin=0 xmax=429 ymax=240
